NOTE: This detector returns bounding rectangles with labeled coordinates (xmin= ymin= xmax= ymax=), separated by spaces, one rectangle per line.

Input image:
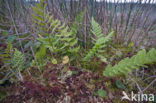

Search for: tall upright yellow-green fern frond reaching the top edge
xmin=32 ymin=0 xmax=61 ymax=36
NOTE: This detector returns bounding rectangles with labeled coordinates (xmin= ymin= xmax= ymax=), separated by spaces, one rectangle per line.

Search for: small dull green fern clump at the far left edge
xmin=0 ymin=42 xmax=25 ymax=84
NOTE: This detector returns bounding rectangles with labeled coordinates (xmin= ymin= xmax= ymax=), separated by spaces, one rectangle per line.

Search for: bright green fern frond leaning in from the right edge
xmin=103 ymin=49 xmax=156 ymax=77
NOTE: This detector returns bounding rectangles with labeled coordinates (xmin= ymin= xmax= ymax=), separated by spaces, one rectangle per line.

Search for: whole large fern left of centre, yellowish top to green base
xmin=33 ymin=0 xmax=80 ymax=60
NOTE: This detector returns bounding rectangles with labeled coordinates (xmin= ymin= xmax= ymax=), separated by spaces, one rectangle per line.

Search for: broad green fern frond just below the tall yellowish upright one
xmin=37 ymin=17 xmax=79 ymax=54
